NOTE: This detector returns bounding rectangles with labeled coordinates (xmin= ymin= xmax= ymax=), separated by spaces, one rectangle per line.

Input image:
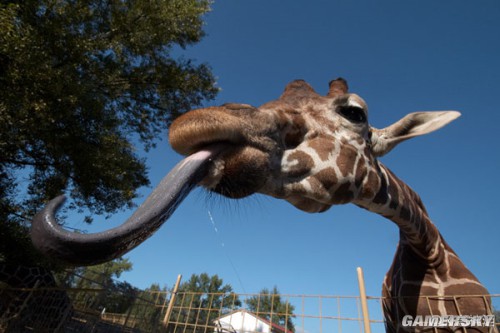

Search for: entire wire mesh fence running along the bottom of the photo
xmin=0 ymin=272 xmax=500 ymax=333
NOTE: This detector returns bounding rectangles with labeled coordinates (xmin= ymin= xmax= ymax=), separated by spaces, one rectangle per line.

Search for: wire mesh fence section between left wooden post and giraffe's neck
xmin=166 ymin=293 xmax=384 ymax=332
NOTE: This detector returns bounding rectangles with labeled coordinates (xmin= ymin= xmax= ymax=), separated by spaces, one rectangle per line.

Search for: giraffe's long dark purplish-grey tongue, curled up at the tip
xmin=31 ymin=145 xmax=223 ymax=266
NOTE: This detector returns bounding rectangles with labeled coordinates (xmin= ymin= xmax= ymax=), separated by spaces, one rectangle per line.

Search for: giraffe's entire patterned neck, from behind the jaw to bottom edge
xmin=364 ymin=164 xmax=496 ymax=326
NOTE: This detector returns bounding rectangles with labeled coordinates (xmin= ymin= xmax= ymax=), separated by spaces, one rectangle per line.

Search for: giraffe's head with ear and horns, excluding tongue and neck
xmin=170 ymin=79 xmax=460 ymax=212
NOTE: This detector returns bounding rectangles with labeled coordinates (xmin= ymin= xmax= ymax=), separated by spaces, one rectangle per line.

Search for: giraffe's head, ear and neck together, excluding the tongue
xmin=170 ymin=79 xmax=491 ymax=332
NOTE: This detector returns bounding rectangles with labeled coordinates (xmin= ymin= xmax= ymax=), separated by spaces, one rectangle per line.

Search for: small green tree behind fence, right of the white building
xmin=245 ymin=286 xmax=295 ymax=332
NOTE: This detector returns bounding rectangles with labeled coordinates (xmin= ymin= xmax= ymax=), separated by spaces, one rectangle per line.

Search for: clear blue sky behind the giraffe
xmin=69 ymin=0 xmax=500 ymax=304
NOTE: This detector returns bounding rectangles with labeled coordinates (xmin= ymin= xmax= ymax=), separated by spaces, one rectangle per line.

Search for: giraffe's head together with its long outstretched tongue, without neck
xmin=31 ymin=79 xmax=460 ymax=265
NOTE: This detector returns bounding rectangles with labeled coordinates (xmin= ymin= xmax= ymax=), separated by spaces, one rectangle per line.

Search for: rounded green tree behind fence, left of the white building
xmin=168 ymin=273 xmax=241 ymax=332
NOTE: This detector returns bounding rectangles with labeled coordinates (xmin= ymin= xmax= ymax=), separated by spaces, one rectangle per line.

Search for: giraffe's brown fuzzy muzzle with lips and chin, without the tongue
xmin=169 ymin=105 xmax=272 ymax=199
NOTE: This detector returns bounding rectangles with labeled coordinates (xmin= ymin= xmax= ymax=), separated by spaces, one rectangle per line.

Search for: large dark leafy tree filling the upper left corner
xmin=0 ymin=0 xmax=217 ymax=264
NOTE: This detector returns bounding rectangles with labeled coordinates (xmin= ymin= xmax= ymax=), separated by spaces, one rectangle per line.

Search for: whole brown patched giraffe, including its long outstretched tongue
xmin=32 ymin=78 xmax=492 ymax=332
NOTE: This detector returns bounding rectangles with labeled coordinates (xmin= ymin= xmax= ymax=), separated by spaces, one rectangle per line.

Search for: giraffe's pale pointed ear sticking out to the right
xmin=370 ymin=111 xmax=460 ymax=157
